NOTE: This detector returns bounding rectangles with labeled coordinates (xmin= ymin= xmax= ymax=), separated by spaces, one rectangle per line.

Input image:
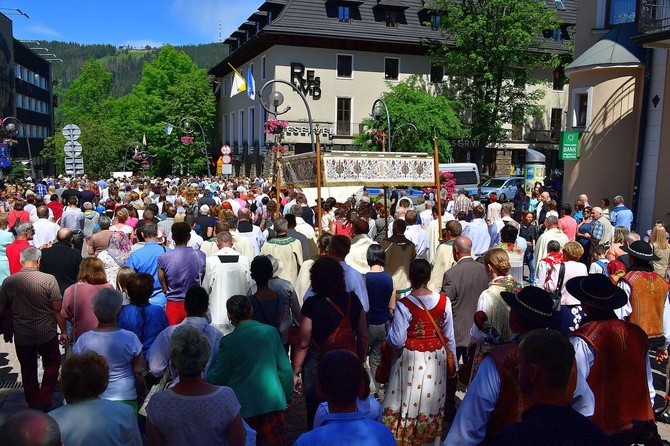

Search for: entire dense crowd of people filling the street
xmin=0 ymin=176 xmax=670 ymax=446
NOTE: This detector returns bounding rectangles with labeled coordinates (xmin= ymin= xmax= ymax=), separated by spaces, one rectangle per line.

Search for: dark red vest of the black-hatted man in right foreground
xmin=573 ymin=319 xmax=654 ymax=434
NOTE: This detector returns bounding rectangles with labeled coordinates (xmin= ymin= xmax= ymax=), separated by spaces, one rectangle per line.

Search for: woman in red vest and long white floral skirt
xmin=383 ymin=259 xmax=456 ymax=445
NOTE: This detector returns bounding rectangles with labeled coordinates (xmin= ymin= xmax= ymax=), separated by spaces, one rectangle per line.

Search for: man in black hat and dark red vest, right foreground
xmin=566 ymin=274 xmax=656 ymax=444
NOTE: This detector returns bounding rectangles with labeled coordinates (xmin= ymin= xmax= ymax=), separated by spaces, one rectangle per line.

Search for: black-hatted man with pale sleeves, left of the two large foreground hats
xmin=444 ymin=288 xmax=605 ymax=446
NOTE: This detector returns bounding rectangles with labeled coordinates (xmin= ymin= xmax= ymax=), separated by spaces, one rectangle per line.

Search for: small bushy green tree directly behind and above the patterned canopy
xmin=354 ymin=77 xmax=463 ymax=162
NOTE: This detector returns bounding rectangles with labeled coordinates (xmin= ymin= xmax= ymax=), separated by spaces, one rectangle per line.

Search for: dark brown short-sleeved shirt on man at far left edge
xmin=0 ymin=268 xmax=63 ymax=345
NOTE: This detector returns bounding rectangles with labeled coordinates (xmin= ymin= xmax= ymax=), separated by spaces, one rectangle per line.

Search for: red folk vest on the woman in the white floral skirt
xmin=402 ymin=294 xmax=447 ymax=352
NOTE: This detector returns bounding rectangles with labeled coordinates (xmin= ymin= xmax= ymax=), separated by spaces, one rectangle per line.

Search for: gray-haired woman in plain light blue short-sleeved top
xmin=72 ymin=288 xmax=146 ymax=414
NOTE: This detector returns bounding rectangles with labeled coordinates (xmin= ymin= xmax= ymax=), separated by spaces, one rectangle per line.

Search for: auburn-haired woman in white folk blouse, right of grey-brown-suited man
xmin=470 ymin=248 xmax=522 ymax=342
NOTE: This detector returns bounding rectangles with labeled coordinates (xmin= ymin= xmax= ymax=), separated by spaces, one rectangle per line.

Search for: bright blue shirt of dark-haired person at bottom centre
xmin=295 ymin=412 xmax=396 ymax=446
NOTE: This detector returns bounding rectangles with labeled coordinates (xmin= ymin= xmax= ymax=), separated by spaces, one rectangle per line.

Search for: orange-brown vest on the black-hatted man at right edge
xmin=623 ymin=271 xmax=668 ymax=338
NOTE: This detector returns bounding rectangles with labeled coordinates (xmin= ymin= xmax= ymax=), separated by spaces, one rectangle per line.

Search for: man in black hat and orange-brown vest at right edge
xmin=616 ymin=240 xmax=670 ymax=360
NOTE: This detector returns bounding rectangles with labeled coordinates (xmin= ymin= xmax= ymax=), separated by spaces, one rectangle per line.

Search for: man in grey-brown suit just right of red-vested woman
xmin=442 ymin=236 xmax=489 ymax=415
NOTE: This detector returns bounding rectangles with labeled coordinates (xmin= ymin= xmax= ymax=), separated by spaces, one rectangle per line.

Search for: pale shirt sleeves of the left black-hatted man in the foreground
xmin=443 ymin=355 xmax=595 ymax=446
